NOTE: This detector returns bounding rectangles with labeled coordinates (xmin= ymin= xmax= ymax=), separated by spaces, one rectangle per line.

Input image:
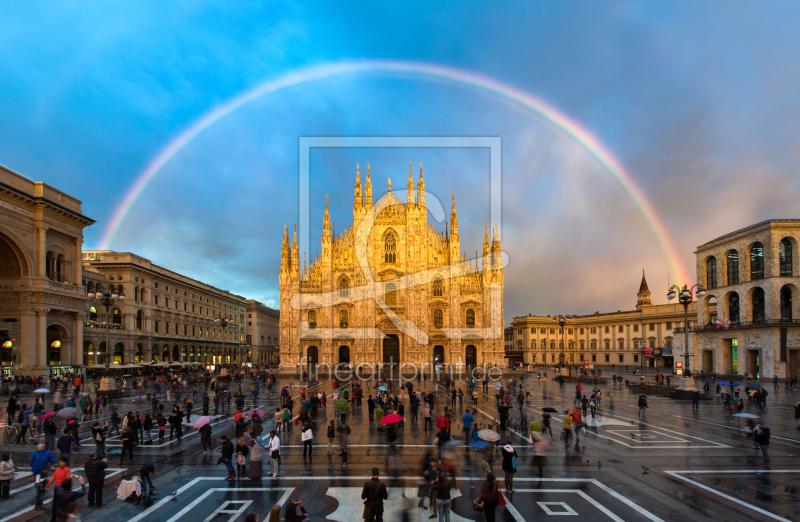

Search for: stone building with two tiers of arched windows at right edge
xmin=679 ymin=219 xmax=800 ymax=378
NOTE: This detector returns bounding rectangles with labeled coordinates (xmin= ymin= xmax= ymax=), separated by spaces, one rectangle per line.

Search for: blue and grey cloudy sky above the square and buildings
xmin=0 ymin=1 xmax=800 ymax=314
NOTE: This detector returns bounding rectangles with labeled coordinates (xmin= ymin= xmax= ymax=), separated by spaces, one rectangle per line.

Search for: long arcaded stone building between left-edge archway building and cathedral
xmin=83 ymin=250 xmax=248 ymax=368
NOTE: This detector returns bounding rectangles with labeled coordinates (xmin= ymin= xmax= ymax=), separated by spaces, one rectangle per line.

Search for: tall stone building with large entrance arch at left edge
xmin=0 ymin=167 xmax=94 ymax=375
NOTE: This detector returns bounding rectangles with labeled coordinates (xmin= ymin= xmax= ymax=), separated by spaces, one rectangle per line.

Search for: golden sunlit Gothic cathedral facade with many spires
xmin=280 ymin=165 xmax=505 ymax=373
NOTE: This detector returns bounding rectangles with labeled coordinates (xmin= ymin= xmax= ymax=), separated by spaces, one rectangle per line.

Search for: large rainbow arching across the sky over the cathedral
xmin=99 ymin=60 xmax=690 ymax=282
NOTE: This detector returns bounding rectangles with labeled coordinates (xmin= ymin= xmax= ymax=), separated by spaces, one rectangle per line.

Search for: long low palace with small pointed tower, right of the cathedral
xmin=511 ymin=273 xmax=696 ymax=371
